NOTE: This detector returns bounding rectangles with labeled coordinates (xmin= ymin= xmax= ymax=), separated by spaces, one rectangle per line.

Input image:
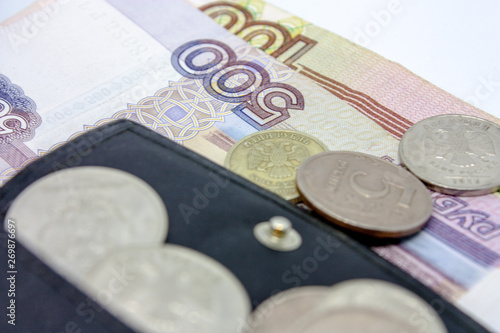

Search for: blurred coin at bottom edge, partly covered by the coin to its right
xmin=246 ymin=286 xmax=331 ymax=333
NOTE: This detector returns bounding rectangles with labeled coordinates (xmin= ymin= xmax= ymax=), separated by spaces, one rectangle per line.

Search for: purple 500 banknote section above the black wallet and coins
xmin=0 ymin=0 xmax=397 ymax=184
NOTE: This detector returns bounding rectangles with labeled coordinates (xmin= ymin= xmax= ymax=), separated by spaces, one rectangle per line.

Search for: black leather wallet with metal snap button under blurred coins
xmin=0 ymin=120 xmax=486 ymax=333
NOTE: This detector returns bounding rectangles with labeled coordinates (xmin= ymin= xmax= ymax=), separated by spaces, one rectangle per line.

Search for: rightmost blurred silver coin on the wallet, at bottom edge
xmin=287 ymin=279 xmax=447 ymax=333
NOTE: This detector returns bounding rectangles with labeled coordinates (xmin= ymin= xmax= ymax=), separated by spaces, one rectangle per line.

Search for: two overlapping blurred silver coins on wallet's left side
xmin=7 ymin=167 xmax=251 ymax=333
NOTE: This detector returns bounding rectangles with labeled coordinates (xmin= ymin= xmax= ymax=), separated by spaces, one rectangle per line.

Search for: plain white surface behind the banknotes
xmin=0 ymin=0 xmax=500 ymax=118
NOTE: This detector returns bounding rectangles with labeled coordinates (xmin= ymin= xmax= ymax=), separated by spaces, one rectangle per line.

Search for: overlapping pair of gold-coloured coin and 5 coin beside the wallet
xmin=225 ymin=130 xmax=432 ymax=238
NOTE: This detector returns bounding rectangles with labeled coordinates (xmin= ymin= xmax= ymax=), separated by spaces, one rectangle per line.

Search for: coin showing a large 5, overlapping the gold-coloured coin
xmin=297 ymin=151 xmax=432 ymax=237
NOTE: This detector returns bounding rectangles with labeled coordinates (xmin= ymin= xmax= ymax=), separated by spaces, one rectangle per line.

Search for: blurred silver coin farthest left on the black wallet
xmin=6 ymin=166 xmax=168 ymax=283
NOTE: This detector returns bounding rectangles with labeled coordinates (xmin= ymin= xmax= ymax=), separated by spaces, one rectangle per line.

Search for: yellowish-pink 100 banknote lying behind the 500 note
xmin=188 ymin=0 xmax=499 ymax=132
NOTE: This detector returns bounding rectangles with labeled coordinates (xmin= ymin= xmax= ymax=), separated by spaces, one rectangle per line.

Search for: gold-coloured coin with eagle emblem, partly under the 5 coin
xmin=225 ymin=130 xmax=328 ymax=202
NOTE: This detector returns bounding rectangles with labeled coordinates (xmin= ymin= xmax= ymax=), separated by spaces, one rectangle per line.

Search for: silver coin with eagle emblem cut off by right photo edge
xmin=399 ymin=114 xmax=500 ymax=196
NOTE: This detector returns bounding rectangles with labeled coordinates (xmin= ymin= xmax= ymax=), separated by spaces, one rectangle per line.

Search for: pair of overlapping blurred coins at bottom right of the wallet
xmin=246 ymin=279 xmax=447 ymax=333
